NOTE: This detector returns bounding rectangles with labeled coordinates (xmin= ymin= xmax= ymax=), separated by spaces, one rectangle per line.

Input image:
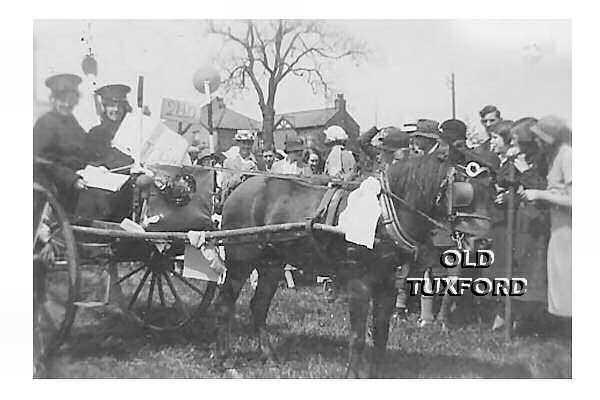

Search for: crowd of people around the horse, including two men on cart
xmin=33 ymin=74 xmax=572 ymax=334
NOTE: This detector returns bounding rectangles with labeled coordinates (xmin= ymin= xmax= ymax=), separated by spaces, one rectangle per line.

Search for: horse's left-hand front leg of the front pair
xmin=346 ymin=278 xmax=369 ymax=378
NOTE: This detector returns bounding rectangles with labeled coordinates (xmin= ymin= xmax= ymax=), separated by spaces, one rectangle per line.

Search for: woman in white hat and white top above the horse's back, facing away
xmin=324 ymin=125 xmax=356 ymax=180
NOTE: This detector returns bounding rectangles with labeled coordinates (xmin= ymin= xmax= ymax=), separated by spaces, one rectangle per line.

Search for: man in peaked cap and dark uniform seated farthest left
xmin=33 ymin=74 xmax=87 ymax=212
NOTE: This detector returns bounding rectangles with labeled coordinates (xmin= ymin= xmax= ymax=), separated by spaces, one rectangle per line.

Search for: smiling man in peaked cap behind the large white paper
xmin=85 ymin=85 xmax=133 ymax=169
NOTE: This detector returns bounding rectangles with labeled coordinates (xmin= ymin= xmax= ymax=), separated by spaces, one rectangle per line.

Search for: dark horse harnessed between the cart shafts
xmin=215 ymin=154 xmax=492 ymax=377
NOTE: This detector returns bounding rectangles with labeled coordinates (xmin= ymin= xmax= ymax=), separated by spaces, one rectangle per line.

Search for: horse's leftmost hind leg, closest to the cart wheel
xmin=215 ymin=261 xmax=250 ymax=358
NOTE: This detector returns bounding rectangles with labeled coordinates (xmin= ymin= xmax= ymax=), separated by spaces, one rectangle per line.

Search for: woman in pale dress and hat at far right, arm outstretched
xmin=520 ymin=116 xmax=572 ymax=317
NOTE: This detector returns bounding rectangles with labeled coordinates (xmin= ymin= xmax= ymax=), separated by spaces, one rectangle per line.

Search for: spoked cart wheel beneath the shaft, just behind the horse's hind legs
xmin=109 ymin=252 xmax=217 ymax=331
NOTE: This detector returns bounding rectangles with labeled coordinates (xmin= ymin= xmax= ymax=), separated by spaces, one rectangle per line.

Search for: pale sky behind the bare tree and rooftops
xmin=33 ymin=20 xmax=572 ymax=139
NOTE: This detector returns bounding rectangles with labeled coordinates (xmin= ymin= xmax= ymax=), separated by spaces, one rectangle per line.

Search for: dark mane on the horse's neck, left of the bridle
xmin=387 ymin=153 xmax=449 ymax=212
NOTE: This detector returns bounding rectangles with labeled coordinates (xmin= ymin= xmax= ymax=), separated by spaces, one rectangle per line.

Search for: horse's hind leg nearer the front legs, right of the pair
xmin=250 ymin=265 xmax=281 ymax=360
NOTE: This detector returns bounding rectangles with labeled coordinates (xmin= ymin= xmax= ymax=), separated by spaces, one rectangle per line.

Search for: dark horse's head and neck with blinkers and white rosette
xmin=388 ymin=154 xmax=495 ymax=252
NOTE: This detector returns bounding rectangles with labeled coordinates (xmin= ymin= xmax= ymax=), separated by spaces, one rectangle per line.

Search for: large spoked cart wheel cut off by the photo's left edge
xmin=33 ymin=183 xmax=79 ymax=367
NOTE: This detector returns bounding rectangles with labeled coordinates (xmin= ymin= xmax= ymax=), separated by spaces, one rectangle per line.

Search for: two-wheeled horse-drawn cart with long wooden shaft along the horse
xmin=33 ymin=162 xmax=341 ymax=372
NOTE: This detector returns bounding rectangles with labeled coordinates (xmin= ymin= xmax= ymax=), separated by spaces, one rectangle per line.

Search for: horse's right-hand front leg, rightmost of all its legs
xmin=370 ymin=275 xmax=396 ymax=378
